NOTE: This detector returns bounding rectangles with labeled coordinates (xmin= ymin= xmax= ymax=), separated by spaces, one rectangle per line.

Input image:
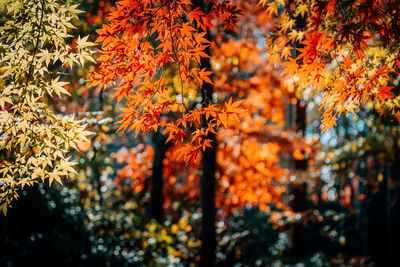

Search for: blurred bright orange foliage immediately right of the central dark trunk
xmin=213 ymin=26 xmax=314 ymax=214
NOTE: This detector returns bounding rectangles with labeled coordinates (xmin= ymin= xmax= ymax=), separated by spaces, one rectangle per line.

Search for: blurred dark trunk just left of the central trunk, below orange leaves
xmin=150 ymin=132 xmax=167 ymax=223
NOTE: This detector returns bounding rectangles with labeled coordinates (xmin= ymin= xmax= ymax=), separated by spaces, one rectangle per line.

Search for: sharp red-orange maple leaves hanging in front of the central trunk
xmin=90 ymin=0 xmax=241 ymax=162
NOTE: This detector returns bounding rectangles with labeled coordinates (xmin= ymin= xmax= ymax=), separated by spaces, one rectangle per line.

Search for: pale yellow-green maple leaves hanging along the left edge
xmin=0 ymin=0 xmax=94 ymax=214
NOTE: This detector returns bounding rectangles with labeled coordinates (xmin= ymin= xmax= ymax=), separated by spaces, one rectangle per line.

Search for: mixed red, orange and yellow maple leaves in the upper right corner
xmin=261 ymin=0 xmax=400 ymax=131
